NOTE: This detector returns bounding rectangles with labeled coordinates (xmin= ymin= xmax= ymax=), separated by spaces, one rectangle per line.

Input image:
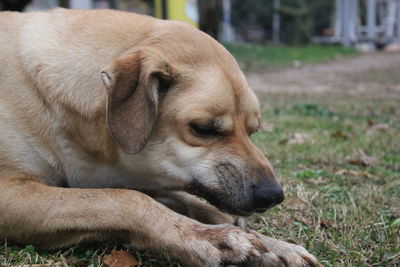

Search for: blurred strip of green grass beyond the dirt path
xmin=225 ymin=44 xmax=357 ymax=71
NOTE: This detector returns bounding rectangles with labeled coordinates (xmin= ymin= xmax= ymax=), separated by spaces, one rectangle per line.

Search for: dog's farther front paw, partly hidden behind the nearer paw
xmin=241 ymin=231 xmax=322 ymax=267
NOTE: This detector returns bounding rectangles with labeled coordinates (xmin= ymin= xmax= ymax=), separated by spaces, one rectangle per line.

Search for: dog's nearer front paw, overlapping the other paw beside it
xmin=181 ymin=225 xmax=267 ymax=266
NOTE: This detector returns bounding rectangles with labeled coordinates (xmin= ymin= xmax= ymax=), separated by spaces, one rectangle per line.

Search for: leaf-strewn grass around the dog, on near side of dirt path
xmin=0 ymin=95 xmax=400 ymax=267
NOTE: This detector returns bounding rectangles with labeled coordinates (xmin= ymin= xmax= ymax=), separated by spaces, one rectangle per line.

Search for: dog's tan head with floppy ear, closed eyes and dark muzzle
xmin=102 ymin=19 xmax=283 ymax=215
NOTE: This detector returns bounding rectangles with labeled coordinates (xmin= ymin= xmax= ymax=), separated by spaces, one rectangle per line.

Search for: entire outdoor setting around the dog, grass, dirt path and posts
xmin=0 ymin=0 xmax=400 ymax=267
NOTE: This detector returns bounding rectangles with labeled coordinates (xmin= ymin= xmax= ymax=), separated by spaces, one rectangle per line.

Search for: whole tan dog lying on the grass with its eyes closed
xmin=0 ymin=9 xmax=317 ymax=266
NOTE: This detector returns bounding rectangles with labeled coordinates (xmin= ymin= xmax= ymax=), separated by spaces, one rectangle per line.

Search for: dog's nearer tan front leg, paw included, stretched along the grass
xmin=0 ymin=176 xmax=265 ymax=266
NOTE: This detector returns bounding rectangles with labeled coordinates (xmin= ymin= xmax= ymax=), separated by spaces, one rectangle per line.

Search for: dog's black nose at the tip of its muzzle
xmin=254 ymin=182 xmax=285 ymax=210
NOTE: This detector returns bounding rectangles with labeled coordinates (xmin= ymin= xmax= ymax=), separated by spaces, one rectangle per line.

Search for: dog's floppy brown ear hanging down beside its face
xmin=101 ymin=52 xmax=172 ymax=154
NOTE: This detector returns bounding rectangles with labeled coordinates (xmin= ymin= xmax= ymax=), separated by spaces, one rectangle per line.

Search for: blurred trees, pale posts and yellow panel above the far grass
xmin=0 ymin=0 xmax=400 ymax=50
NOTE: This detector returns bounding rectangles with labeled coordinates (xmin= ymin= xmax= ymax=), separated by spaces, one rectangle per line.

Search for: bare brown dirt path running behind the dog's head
xmin=246 ymin=52 xmax=400 ymax=99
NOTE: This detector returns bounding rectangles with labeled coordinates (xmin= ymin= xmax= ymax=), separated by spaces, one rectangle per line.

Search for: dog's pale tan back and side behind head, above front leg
xmin=0 ymin=9 xmax=146 ymax=184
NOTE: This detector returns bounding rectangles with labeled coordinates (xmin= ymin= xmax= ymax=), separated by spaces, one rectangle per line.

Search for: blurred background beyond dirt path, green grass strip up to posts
xmin=0 ymin=0 xmax=400 ymax=71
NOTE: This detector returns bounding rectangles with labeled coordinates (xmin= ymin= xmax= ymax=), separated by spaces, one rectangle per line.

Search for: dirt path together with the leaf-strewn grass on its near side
xmin=0 ymin=49 xmax=400 ymax=267
